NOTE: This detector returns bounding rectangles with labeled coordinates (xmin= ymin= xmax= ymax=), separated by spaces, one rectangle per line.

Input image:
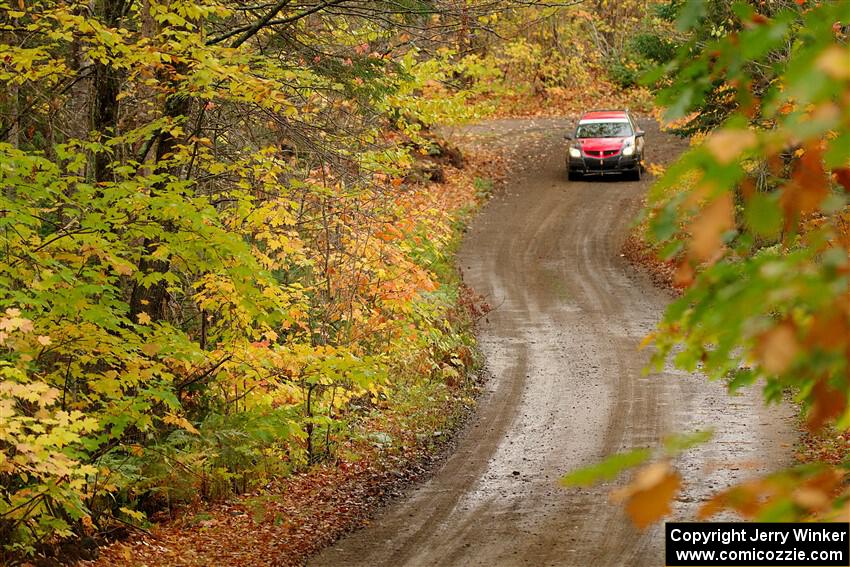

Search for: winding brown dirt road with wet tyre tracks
xmin=310 ymin=120 xmax=794 ymax=567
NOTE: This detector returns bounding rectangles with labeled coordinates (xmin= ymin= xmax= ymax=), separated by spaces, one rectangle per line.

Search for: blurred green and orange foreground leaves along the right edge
xmin=628 ymin=2 xmax=850 ymax=520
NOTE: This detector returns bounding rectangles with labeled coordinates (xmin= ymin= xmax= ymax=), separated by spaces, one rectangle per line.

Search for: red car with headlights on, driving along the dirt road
xmin=565 ymin=110 xmax=644 ymax=180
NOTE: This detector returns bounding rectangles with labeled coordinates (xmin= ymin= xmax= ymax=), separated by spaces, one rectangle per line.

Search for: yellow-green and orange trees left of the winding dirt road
xmin=0 ymin=0 xmax=504 ymax=555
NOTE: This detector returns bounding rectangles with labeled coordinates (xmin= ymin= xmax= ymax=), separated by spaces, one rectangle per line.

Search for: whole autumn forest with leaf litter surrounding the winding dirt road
xmin=0 ymin=0 xmax=850 ymax=565
